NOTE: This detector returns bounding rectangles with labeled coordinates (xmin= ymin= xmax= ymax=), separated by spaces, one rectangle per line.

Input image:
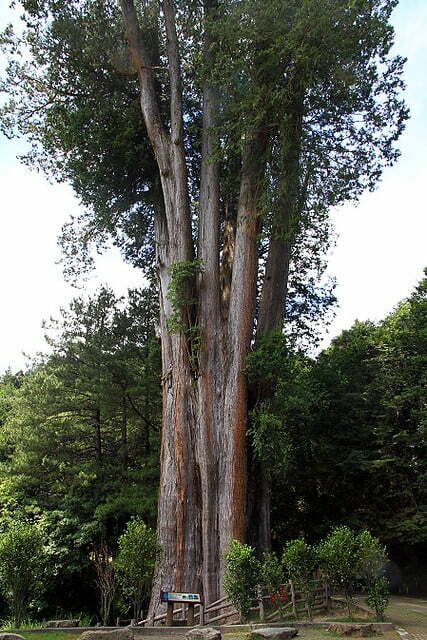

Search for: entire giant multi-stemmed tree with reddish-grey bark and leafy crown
xmin=3 ymin=0 xmax=407 ymax=608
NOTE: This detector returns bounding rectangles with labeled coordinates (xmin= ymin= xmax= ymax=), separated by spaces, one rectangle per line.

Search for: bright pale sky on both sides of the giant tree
xmin=0 ymin=0 xmax=427 ymax=373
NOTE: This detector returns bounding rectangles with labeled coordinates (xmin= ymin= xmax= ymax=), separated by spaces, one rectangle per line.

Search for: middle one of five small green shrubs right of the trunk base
xmin=283 ymin=538 xmax=318 ymax=620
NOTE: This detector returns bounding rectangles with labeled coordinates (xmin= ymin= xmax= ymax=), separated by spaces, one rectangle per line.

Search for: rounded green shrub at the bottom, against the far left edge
xmin=0 ymin=520 xmax=44 ymax=627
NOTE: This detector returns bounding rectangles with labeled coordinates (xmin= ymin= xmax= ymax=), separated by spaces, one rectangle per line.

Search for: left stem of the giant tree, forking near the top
xmin=121 ymin=0 xmax=201 ymax=609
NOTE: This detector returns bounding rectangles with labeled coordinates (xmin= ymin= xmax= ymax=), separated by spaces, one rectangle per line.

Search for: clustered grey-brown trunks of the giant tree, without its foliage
xmin=121 ymin=0 xmax=282 ymax=616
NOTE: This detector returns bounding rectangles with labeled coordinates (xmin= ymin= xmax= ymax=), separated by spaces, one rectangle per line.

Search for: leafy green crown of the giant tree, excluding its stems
xmin=0 ymin=0 xmax=408 ymax=339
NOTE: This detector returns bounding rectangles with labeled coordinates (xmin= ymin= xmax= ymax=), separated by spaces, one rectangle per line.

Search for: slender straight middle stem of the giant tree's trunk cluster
xmin=197 ymin=0 xmax=224 ymax=602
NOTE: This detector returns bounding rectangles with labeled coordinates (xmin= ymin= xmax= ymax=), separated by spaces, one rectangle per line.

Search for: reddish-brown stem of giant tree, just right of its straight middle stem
xmin=219 ymin=132 xmax=265 ymax=579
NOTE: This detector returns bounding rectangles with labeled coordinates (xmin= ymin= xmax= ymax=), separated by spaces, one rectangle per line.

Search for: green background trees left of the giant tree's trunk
xmin=0 ymin=289 xmax=161 ymax=617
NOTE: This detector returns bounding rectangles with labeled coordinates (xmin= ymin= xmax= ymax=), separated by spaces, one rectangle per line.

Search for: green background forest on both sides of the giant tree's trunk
xmin=0 ymin=278 xmax=427 ymax=616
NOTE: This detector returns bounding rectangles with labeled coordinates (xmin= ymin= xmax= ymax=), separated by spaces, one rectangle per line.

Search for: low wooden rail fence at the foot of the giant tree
xmin=137 ymin=580 xmax=330 ymax=626
